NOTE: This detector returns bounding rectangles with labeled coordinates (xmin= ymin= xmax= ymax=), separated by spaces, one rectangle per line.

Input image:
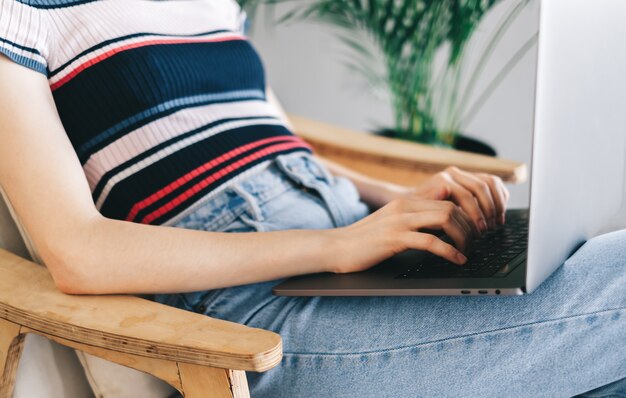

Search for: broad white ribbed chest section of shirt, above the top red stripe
xmin=44 ymin=0 xmax=241 ymax=70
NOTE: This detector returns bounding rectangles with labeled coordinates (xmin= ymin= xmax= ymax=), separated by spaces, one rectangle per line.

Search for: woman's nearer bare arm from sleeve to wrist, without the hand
xmin=0 ymin=57 xmax=342 ymax=293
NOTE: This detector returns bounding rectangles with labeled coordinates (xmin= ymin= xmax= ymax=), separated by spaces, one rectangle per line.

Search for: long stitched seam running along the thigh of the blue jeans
xmin=283 ymin=307 xmax=626 ymax=357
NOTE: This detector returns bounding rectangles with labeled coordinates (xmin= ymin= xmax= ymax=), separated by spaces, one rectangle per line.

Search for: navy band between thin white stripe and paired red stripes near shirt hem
xmin=100 ymin=125 xmax=308 ymax=219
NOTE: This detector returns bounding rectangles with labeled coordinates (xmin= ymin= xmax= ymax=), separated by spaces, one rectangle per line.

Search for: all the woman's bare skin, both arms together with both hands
xmin=0 ymin=56 xmax=508 ymax=294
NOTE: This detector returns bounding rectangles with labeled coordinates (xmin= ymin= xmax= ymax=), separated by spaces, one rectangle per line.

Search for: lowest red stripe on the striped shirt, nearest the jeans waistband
xmin=141 ymin=142 xmax=308 ymax=224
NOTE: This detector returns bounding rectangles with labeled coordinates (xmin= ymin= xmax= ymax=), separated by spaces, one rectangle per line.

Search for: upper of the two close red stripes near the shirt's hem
xmin=126 ymin=136 xmax=304 ymax=221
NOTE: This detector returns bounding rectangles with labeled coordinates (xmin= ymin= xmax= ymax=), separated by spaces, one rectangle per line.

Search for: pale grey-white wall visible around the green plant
xmin=250 ymin=0 xmax=538 ymax=207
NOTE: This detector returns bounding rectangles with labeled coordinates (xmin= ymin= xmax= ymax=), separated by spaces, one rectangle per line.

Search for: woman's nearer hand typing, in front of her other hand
xmin=329 ymin=199 xmax=479 ymax=273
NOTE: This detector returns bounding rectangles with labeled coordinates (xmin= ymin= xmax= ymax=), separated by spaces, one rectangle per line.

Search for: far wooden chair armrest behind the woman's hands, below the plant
xmin=289 ymin=115 xmax=527 ymax=185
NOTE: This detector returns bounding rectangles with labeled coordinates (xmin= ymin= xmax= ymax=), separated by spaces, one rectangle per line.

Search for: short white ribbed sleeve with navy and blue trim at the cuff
xmin=0 ymin=0 xmax=48 ymax=76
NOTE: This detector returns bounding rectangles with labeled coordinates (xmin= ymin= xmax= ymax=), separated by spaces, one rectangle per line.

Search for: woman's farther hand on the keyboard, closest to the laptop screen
xmin=402 ymin=167 xmax=509 ymax=232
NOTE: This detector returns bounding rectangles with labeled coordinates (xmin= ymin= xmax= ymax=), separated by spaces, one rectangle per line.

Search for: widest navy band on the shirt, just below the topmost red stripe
xmin=53 ymin=40 xmax=265 ymax=158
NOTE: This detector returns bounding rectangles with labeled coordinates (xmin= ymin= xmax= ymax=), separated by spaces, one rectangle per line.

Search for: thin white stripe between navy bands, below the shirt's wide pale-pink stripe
xmin=96 ymin=119 xmax=282 ymax=209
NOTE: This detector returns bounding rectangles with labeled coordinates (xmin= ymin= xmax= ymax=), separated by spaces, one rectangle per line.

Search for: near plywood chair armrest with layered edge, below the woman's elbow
xmin=0 ymin=249 xmax=282 ymax=371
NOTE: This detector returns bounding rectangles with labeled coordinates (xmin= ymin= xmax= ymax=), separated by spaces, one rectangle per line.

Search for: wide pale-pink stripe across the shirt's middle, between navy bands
xmin=83 ymin=100 xmax=278 ymax=190
